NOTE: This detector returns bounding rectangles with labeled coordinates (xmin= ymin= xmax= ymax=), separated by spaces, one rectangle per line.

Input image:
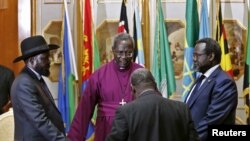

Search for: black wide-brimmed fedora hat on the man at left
xmin=13 ymin=35 xmax=59 ymax=63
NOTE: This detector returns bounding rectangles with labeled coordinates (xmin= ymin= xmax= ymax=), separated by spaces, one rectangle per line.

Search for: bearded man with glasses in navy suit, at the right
xmin=185 ymin=38 xmax=238 ymax=141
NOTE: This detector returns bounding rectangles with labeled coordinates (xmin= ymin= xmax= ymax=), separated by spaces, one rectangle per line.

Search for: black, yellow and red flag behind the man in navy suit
xmin=216 ymin=1 xmax=233 ymax=77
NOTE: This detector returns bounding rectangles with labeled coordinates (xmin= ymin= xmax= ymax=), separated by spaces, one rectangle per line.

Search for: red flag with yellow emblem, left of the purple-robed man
xmin=82 ymin=0 xmax=100 ymax=141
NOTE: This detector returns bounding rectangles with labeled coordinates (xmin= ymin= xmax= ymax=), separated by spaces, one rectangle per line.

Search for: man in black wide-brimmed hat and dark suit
xmin=11 ymin=35 xmax=67 ymax=141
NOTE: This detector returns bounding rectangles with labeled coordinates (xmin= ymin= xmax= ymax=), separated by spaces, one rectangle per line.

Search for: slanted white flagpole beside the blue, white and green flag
xmin=64 ymin=0 xmax=78 ymax=81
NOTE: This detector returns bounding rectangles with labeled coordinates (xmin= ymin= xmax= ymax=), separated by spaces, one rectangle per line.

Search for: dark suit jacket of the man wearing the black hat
xmin=11 ymin=67 xmax=66 ymax=141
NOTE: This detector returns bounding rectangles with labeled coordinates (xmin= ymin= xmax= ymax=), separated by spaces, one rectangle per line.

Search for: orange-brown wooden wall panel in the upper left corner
xmin=0 ymin=0 xmax=20 ymax=74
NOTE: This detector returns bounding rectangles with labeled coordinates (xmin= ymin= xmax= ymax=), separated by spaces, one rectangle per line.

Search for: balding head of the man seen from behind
xmin=131 ymin=68 xmax=157 ymax=97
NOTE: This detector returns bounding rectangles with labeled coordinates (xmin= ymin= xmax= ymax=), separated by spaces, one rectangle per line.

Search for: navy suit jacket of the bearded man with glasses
xmin=188 ymin=67 xmax=238 ymax=140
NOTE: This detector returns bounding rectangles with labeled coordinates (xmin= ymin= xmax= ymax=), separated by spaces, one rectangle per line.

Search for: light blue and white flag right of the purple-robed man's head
xmin=134 ymin=1 xmax=145 ymax=66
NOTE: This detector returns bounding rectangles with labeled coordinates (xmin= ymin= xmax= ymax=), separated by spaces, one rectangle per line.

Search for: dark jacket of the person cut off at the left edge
xmin=0 ymin=65 xmax=15 ymax=114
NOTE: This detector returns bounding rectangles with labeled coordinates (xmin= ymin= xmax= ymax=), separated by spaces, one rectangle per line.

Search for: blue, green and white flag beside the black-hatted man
xmin=58 ymin=11 xmax=77 ymax=132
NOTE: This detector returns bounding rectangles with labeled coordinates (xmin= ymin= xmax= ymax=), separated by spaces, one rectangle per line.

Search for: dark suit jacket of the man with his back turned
xmin=106 ymin=91 xmax=198 ymax=141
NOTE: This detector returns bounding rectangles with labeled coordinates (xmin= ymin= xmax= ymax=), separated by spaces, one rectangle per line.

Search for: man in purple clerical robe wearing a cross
xmin=68 ymin=33 xmax=142 ymax=141
